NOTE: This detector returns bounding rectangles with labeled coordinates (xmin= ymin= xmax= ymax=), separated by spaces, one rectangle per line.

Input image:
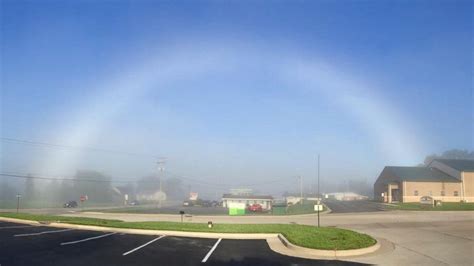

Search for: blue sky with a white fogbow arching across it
xmin=1 ymin=1 xmax=474 ymax=193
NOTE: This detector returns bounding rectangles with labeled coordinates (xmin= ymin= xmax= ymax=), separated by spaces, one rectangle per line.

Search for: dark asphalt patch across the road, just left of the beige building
xmin=324 ymin=200 xmax=385 ymax=213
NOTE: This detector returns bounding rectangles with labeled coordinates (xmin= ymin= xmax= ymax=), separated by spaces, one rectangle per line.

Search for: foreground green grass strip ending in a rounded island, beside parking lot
xmin=0 ymin=213 xmax=376 ymax=250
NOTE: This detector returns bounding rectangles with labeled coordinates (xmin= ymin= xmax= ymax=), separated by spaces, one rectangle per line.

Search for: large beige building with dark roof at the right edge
xmin=374 ymin=159 xmax=474 ymax=203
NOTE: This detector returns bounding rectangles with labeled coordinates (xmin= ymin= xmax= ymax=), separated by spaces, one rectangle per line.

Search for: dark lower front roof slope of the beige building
xmin=384 ymin=166 xmax=461 ymax=182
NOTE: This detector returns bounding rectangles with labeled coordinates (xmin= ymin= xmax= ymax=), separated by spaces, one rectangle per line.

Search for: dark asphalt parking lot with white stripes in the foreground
xmin=0 ymin=222 xmax=364 ymax=266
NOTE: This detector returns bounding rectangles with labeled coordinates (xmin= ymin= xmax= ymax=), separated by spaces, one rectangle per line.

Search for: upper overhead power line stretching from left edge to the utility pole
xmin=0 ymin=137 xmax=160 ymax=159
